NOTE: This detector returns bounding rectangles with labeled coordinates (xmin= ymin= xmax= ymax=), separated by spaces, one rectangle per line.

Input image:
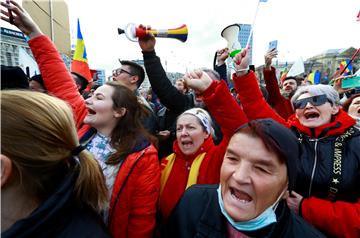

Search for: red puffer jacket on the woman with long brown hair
xmin=29 ymin=35 xmax=160 ymax=237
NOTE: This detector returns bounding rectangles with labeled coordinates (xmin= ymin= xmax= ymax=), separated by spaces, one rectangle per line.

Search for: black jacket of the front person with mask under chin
xmin=164 ymin=185 xmax=324 ymax=238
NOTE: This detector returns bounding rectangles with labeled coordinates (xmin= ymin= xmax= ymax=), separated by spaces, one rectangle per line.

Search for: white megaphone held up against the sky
xmin=221 ymin=24 xmax=241 ymax=57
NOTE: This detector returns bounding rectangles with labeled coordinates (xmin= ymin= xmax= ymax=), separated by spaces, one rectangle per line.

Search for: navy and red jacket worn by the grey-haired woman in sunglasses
xmin=233 ymin=73 xmax=360 ymax=237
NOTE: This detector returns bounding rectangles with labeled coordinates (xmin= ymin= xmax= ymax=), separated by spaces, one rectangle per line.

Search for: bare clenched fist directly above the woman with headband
xmin=184 ymin=69 xmax=213 ymax=94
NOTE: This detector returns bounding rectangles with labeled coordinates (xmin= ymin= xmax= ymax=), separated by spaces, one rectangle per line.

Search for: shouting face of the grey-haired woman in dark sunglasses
xmin=294 ymin=93 xmax=339 ymax=128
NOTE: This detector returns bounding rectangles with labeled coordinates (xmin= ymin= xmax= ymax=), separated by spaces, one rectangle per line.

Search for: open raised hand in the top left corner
xmin=0 ymin=0 xmax=42 ymax=39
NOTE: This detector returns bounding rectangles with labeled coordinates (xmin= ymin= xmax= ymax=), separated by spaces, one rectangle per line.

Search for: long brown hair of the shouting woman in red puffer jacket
xmin=106 ymin=81 xmax=156 ymax=164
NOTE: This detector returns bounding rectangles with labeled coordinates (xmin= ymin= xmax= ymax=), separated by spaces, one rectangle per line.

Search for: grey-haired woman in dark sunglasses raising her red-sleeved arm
xmin=233 ymin=49 xmax=360 ymax=237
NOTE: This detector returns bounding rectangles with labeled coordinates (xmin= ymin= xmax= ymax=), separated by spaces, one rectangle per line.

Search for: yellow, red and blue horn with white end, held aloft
xmin=118 ymin=23 xmax=188 ymax=42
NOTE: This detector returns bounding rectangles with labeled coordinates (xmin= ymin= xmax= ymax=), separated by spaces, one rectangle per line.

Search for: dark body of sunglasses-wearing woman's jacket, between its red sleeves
xmin=294 ymin=124 xmax=360 ymax=203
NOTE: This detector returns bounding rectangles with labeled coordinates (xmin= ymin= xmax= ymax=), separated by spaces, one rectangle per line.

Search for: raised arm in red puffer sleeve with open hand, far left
xmin=1 ymin=0 xmax=87 ymax=129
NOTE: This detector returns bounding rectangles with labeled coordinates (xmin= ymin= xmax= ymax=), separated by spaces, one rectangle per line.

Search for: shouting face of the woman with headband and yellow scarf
xmin=176 ymin=114 xmax=209 ymax=155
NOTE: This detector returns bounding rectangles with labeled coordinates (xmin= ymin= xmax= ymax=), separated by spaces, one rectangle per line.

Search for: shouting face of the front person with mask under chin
xmin=220 ymin=133 xmax=288 ymax=222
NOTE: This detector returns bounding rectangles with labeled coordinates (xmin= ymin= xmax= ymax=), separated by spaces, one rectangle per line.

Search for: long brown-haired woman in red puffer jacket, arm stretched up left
xmin=1 ymin=0 xmax=160 ymax=237
